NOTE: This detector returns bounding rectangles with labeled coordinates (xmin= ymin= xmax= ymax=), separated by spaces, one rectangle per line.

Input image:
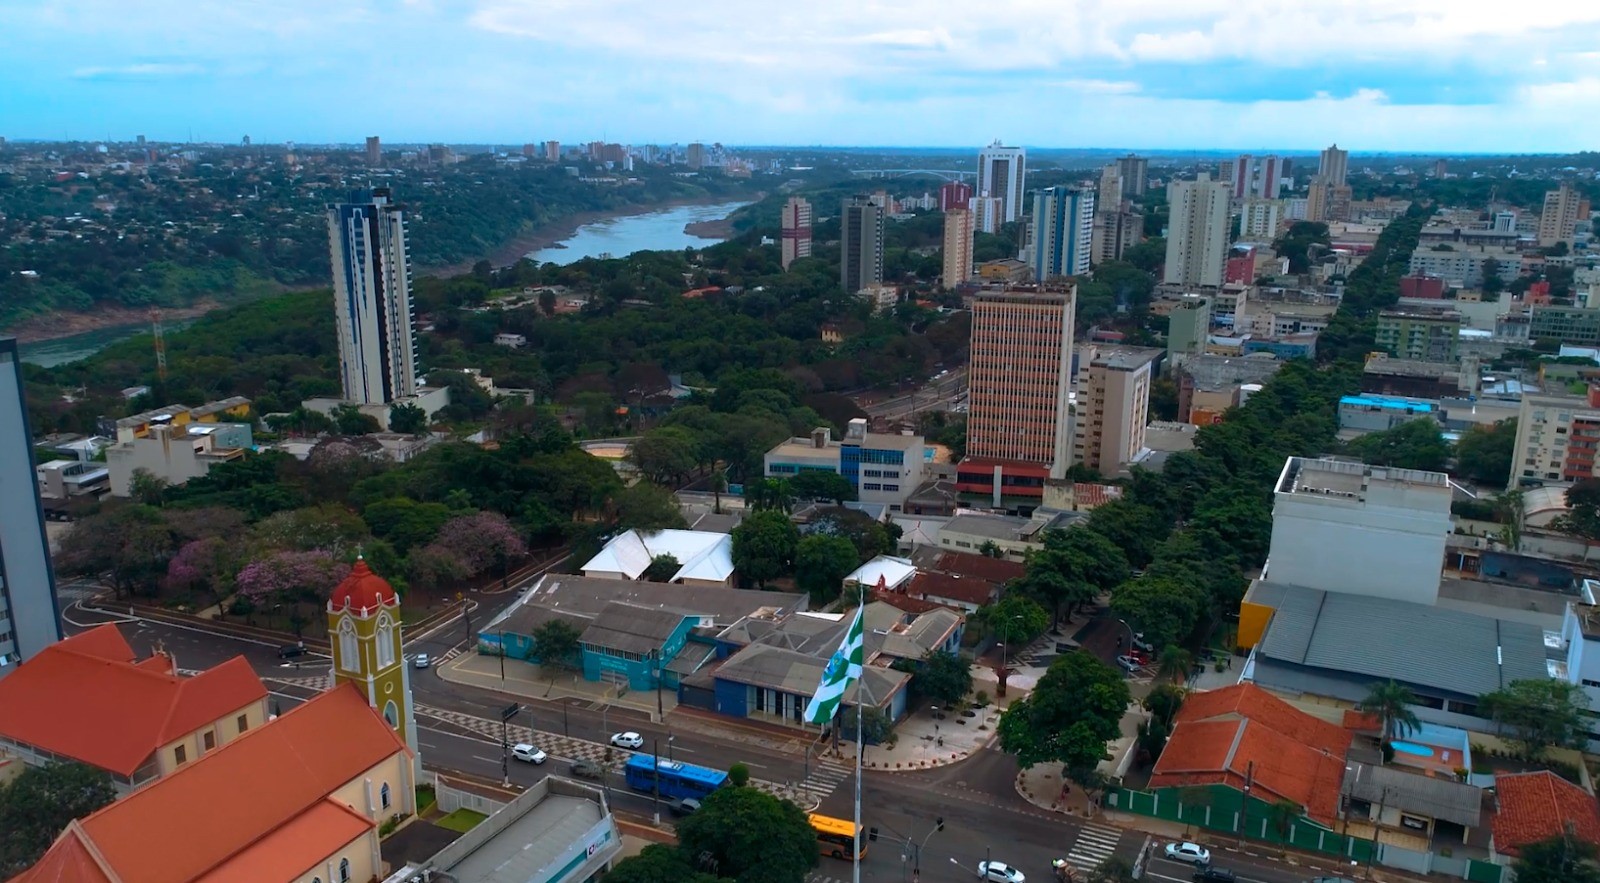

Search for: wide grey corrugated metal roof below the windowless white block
xmin=1259 ymin=585 xmax=1549 ymax=696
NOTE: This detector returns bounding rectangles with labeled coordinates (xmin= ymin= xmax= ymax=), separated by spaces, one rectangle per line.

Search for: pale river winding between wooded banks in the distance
xmin=21 ymin=200 xmax=750 ymax=368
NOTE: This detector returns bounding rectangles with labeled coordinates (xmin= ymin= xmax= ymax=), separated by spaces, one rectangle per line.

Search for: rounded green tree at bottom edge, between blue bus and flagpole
xmin=678 ymin=789 xmax=818 ymax=883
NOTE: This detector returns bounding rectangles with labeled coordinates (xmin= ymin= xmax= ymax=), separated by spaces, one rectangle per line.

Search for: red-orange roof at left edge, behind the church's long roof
xmin=0 ymin=625 xmax=267 ymax=776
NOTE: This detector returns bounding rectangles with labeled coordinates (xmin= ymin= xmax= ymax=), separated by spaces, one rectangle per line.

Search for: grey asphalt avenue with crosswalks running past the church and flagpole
xmin=67 ymin=592 xmax=1344 ymax=883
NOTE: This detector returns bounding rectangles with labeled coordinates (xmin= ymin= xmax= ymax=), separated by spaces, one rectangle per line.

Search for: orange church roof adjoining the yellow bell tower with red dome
xmin=11 ymin=687 xmax=410 ymax=883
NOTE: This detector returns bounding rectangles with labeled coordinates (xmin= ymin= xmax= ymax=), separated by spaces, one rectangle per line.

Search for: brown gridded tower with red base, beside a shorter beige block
xmin=966 ymin=283 xmax=1077 ymax=478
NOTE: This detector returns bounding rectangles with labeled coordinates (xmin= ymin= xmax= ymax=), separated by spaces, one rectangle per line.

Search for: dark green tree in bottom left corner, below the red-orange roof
xmin=0 ymin=761 xmax=117 ymax=878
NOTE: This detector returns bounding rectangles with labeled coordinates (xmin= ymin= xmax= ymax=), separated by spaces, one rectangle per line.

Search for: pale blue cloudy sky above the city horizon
xmin=9 ymin=0 xmax=1600 ymax=154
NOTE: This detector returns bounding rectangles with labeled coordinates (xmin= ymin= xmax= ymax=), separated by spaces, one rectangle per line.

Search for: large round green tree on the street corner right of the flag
xmin=1000 ymin=653 xmax=1131 ymax=769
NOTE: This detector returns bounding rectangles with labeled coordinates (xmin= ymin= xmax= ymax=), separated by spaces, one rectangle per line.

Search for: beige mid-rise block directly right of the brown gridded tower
xmin=1072 ymin=346 xmax=1160 ymax=473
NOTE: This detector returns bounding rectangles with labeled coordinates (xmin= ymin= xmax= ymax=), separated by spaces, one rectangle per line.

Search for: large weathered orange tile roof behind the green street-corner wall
xmin=1150 ymin=685 xmax=1350 ymax=824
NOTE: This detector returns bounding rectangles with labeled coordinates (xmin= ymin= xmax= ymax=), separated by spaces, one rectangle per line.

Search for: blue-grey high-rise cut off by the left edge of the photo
xmin=0 ymin=338 xmax=61 ymax=677
